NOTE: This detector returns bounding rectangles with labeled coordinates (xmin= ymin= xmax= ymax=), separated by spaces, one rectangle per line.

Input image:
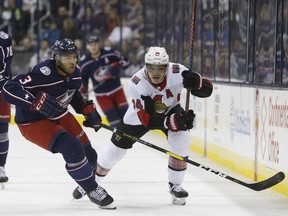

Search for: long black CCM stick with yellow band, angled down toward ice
xmin=101 ymin=124 xmax=285 ymax=191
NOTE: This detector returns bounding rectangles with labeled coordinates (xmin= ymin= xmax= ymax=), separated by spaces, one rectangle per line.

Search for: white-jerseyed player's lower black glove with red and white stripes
xmin=166 ymin=112 xmax=187 ymax=132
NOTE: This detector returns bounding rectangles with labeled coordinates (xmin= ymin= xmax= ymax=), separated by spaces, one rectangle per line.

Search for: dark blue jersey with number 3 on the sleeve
xmin=2 ymin=59 xmax=84 ymax=123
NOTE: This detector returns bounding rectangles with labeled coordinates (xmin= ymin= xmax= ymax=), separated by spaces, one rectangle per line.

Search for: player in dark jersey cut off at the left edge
xmin=0 ymin=31 xmax=13 ymax=185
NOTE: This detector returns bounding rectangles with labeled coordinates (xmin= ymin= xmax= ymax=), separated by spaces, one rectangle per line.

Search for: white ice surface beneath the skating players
xmin=0 ymin=125 xmax=288 ymax=216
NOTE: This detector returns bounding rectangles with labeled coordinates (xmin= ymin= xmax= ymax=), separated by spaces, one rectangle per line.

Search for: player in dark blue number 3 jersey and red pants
xmin=2 ymin=38 xmax=115 ymax=209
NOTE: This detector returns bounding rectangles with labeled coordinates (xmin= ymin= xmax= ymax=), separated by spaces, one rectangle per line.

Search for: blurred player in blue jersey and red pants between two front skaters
xmin=79 ymin=34 xmax=130 ymax=127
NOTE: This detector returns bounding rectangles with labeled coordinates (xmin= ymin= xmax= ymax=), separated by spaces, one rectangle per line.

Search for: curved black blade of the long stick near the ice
xmin=248 ymin=172 xmax=285 ymax=191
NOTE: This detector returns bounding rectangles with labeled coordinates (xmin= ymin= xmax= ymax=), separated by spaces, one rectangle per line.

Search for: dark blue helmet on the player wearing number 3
xmin=51 ymin=38 xmax=79 ymax=57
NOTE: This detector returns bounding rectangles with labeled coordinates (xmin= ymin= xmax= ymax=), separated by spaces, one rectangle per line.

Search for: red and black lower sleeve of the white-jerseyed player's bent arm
xmin=137 ymin=110 xmax=166 ymax=130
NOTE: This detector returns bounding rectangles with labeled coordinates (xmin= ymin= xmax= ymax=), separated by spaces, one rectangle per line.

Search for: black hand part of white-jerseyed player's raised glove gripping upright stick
xmin=182 ymin=70 xmax=202 ymax=90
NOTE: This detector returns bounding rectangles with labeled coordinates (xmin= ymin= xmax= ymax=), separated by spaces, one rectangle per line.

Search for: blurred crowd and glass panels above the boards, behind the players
xmin=0 ymin=0 xmax=288 ymax=87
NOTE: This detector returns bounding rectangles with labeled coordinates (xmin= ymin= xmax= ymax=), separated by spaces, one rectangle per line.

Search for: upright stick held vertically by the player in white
xmin=185 ymin=0 xmax=197 ymax=112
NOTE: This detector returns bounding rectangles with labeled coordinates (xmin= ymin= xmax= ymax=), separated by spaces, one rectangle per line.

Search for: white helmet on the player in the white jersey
xmin=145 ymin=47 xmax=169 ymax=65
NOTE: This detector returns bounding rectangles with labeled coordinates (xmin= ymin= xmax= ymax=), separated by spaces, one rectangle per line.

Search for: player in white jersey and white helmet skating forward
xmin=73 ymin=47 xmax=213 ymax=205
